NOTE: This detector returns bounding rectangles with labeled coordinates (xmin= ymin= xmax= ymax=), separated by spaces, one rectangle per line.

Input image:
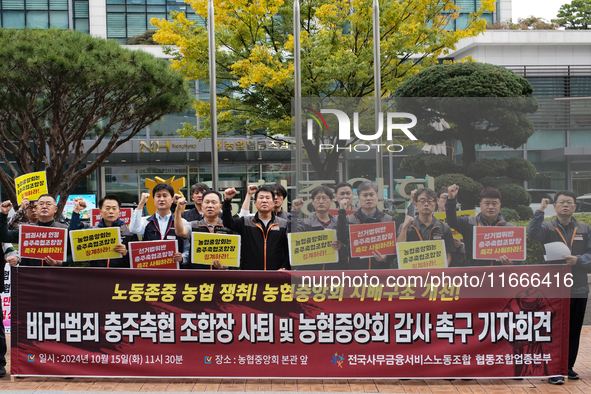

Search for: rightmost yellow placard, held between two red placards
xmin=396 ymin=240 xmax=447 ymax=269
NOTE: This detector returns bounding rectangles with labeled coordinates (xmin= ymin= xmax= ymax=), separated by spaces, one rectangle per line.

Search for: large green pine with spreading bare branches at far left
xmin=0 ymin=29 xmax=192 ymax=212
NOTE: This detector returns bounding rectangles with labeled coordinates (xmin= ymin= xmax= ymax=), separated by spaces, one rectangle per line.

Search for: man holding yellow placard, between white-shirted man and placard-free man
xmin=174 ymin=190 xmax=236 ymax=269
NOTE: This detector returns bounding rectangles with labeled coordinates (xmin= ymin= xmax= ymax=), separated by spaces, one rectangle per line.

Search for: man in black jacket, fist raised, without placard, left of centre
xmin=222 ymin=186 xmax=290 ymax=271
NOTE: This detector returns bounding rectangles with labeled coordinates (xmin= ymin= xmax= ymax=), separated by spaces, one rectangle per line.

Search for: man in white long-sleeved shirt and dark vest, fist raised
xmin=129 ymin=183 xmax=191 ymax=264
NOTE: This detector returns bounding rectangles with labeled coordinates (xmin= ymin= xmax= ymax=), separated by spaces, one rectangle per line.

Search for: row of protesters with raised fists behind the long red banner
xmin=0 ymin=182 xmax=591 ymax=384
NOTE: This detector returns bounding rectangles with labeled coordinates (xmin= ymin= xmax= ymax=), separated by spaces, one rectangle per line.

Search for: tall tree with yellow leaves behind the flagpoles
xmin=152 ymin=0 xmax=495 ymax=179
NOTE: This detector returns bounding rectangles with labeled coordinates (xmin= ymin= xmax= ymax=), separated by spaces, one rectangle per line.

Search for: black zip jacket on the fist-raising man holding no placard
xmin=222 ymin=200 xmax=290 ymax=271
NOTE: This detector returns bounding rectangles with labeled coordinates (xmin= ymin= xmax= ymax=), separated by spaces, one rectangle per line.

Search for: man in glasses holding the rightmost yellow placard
xmin=396 ymin=189 xmax=455 ymax=264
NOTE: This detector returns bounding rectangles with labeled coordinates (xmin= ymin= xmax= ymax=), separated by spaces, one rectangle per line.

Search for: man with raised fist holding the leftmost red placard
xmin=0 ymin=194 xmax=71 ymax=266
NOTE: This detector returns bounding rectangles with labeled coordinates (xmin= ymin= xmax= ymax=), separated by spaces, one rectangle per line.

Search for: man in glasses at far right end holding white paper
xmin=527 ymin=190 xmax=591 ymax=384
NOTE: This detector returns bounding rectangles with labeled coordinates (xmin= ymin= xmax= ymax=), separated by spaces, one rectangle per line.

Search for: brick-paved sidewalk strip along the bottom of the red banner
xmin=0 ymin=326 xmax=591 ymax=394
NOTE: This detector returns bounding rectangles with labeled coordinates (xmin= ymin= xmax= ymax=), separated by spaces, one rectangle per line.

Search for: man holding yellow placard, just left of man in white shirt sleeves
xmin=70 ymin=194 xmax=138 ymax=268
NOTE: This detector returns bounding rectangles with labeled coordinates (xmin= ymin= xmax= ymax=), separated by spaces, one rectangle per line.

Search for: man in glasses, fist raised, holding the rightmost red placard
xmin=445 ymin=185 xmax=515 ymax=266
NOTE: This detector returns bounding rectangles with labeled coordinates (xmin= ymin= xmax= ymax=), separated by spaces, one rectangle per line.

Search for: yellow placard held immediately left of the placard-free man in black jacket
xmin=191 ymin=232 xmax=240 ymax=267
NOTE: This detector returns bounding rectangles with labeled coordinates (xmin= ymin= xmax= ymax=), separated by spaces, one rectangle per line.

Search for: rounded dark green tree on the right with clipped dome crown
xmin=394 ymin=63 xmax=538 ymax=170
